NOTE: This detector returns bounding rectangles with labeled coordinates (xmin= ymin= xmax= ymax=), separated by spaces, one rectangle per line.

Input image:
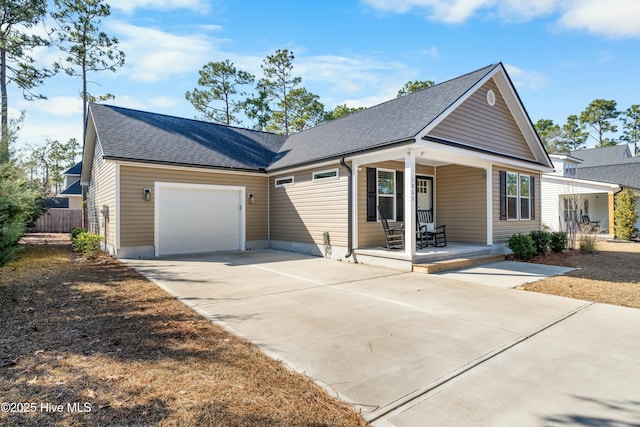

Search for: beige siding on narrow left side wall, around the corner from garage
xmin=87 ymin=140 xmax=117 ymax=253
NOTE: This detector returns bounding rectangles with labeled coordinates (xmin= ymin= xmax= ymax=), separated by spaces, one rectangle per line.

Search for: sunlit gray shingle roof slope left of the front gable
xmin=270 ymin=64 xmax=499 ymax=169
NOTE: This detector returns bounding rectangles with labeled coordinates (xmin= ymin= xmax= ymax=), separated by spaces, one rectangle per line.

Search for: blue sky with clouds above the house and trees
xmin=9 ymin=0 xmax=640 ymax=157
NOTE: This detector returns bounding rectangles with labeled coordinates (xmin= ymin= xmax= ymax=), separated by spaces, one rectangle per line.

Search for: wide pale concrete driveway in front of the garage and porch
xmin=127 ymin=250 xmax=640 ymax=426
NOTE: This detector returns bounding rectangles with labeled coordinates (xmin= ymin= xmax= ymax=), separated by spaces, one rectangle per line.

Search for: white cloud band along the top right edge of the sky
xmin=363 ymin=0 xmax=640 ymax=37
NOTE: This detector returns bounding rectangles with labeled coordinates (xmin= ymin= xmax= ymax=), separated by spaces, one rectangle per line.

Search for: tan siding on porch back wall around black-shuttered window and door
xmin=357 ymin=161 xmax=438 ymax=248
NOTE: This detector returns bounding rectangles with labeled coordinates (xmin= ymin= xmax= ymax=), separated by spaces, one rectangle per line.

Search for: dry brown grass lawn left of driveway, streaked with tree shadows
xmin=0 ymin=245 xmax=366 ymax=426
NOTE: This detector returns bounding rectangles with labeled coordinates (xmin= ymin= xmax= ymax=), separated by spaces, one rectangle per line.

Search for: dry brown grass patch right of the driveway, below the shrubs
xmin=524 ymin=241 xmax=640 ymax=308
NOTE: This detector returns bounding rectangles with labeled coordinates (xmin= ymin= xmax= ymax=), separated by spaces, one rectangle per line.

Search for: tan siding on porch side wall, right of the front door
xmin=436 ymin=165 xmax=487 ymax=244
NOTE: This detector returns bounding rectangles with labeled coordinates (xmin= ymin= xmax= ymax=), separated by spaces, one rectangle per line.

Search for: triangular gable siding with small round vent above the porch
xmin=429 ymin=79 xmax=535 ymax=160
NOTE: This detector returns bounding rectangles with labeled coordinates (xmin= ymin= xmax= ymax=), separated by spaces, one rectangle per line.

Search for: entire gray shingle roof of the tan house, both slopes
xmin=90 ymin=64 xmax=500 ymax=170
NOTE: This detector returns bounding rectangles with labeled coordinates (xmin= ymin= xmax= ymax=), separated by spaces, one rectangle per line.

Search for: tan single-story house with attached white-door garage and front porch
xmin=81 ymin=63 xmax=552 ymax=268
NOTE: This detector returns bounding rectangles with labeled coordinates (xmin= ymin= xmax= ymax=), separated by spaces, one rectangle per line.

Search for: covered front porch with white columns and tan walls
xmin=351 ymin=141 xmax=497 ymax=264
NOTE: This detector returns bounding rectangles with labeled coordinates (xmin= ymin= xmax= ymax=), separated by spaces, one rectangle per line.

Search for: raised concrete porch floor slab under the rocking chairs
xmin=354 ymin=242 xmax=495 ymax=271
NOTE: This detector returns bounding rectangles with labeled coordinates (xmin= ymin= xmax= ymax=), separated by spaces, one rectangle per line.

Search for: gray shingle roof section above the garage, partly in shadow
xmin=91 ymin=104 xmax=286 ymax=170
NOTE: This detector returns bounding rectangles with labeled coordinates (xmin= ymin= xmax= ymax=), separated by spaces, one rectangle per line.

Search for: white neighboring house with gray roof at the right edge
xmin=541 ymin=145 xmax=640 ymax=238
